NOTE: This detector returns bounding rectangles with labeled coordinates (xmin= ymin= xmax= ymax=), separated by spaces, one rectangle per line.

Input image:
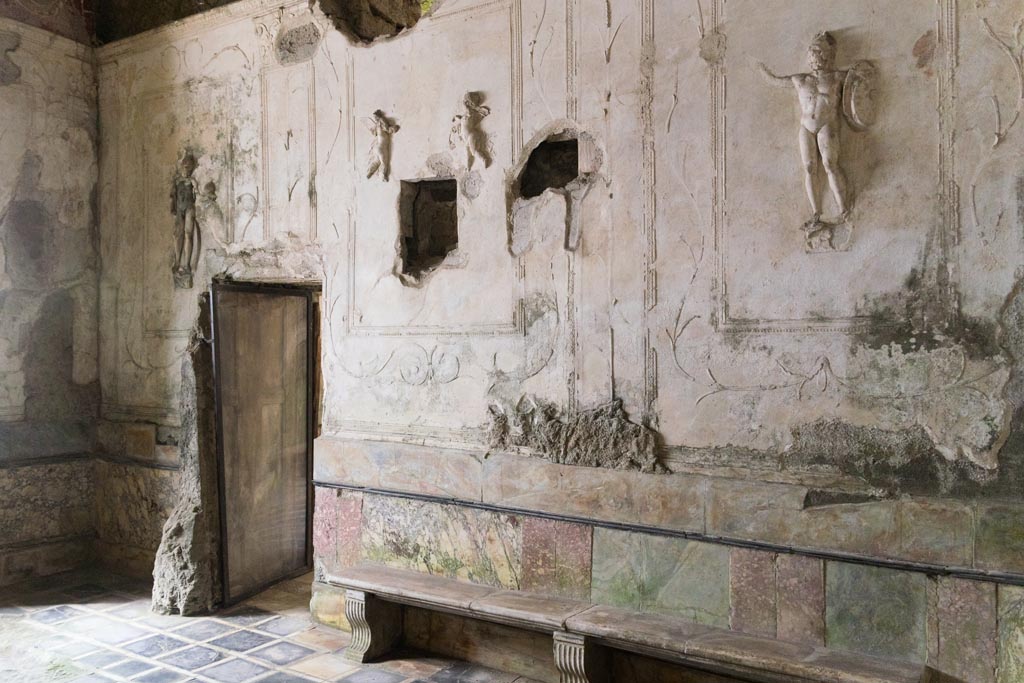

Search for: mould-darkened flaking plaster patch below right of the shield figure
xmin=844 ymin=268 xmax=1015 ymax=470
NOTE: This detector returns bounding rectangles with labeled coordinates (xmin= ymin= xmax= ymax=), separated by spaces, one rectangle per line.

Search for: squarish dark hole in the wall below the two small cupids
xmin=399 ymin=178 xmax=459 ymax=282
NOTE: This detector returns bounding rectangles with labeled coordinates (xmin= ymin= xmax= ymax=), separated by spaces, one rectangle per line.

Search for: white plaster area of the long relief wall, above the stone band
xmin=98 ymin=0 xmax=1024 ymax=491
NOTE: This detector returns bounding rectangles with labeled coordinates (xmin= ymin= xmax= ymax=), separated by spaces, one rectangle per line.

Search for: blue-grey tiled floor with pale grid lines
xmin=0 ymin=572 xmax=530 ymax=683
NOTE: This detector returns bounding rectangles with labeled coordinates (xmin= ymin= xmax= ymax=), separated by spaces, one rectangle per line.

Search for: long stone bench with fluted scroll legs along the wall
xmin=327 ymin=564 xmax=930 ymax=683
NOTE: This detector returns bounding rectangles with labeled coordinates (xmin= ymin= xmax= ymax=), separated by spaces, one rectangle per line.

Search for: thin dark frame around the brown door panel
xmin=210 ymin=280 xmax=321 ymax=607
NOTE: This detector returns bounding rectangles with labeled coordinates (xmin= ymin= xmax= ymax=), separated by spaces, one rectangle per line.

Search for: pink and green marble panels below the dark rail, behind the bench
xmin=311 ymin=486 xmax=1024 ymax=683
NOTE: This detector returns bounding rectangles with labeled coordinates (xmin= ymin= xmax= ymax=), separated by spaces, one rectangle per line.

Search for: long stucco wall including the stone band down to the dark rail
xmin=98 ymin=0 xmax=1024 ymax=680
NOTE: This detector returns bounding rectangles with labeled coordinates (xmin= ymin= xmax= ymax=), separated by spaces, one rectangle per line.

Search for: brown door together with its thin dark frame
xmin=213 ymin=283 xmax=318 ymax=604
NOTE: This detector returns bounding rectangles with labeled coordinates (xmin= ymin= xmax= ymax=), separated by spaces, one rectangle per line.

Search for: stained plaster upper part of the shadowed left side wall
xmin=0 ymin=14 xmax=98 ymax=456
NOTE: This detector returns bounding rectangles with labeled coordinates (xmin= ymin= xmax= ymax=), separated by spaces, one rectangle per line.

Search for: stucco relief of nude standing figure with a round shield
xmin=758 ymin=31 xmax=878 ymax=251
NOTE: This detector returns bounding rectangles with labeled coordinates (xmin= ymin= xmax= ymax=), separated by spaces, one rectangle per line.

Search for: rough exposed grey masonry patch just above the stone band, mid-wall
xmin=487 ymin=397 xmax=668 ymax=473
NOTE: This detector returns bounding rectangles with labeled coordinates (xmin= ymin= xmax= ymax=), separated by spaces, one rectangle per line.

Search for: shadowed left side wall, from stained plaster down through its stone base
xmin=0 ymin=18 xmax=99 ymax=583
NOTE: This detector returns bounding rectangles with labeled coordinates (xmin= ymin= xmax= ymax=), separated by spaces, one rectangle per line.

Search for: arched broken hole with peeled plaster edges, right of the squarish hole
xmin=508 ymin=121 xmax=604 ymax=257
